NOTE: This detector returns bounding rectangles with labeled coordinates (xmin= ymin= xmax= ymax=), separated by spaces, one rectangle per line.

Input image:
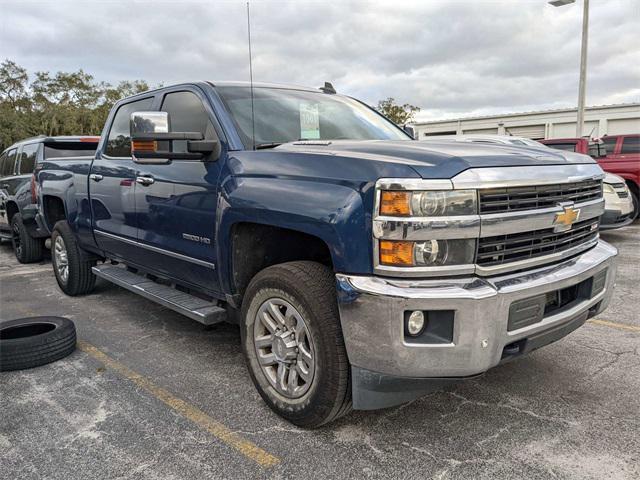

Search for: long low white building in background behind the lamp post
xmin=412 ymin=103 xmax=640 ymax=140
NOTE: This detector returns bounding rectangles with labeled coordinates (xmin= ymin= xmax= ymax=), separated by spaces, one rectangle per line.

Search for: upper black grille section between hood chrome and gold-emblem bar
xmin=479 ymin=180 xmax=602 ymax=213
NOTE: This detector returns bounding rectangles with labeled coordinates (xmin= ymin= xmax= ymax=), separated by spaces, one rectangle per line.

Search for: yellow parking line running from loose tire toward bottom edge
xmin=78 ymin=341 xmax=280 ymax=467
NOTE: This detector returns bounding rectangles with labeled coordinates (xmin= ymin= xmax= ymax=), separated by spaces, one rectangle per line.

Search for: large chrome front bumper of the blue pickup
xmin=336 ymin=241 xmax=617 ymax=408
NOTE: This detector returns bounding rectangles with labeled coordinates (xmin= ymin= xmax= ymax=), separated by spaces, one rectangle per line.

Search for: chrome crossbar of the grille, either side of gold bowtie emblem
xmin=479 ymin=198 xmax=604 ymax=238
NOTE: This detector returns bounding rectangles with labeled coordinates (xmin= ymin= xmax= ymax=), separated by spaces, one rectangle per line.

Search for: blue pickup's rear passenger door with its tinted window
xmin=88 ymin=96 xmax=154 ymax=260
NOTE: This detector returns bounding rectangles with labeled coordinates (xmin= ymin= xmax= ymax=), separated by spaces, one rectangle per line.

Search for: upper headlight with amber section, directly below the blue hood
xmin=380 ymin=190 xmax=478 ymax=217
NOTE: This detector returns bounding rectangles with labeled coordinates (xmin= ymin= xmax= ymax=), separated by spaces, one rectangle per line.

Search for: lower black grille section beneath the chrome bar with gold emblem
xmin=476 ymin=218 xmax=598 ymax=266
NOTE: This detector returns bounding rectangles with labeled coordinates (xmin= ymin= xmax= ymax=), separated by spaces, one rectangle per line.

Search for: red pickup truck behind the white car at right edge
xmin=540 ymin=134 xmax=640 ymax=217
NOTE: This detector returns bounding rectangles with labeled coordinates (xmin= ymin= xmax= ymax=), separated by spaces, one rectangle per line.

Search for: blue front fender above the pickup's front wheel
xmin=216 ymin=172 xmax=375 ymax=292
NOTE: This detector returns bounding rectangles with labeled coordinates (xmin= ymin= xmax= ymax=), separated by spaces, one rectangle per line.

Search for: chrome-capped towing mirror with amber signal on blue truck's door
xmin=130 ymin=112 xmax=220 ymax=164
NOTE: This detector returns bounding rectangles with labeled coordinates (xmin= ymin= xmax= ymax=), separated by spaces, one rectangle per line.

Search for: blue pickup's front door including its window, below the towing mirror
xmin=136 ymin=89 xmax=220 ymax=293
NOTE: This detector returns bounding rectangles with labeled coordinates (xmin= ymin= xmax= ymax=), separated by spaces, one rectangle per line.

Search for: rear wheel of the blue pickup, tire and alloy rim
xmin=51 ymin=220 xmax=96 ymax=297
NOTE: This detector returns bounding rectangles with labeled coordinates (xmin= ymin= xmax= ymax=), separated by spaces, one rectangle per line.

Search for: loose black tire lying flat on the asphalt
xmin=0 ymin=317 xmax=76 ymax=372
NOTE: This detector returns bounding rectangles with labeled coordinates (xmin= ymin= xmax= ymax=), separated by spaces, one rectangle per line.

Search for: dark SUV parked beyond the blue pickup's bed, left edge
xmin=0 ymin=136 xmax=100 ymax=263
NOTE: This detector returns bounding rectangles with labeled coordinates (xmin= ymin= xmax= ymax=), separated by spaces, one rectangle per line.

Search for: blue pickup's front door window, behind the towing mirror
xmin=160 ymin=92 xmax=216 ymax=152
